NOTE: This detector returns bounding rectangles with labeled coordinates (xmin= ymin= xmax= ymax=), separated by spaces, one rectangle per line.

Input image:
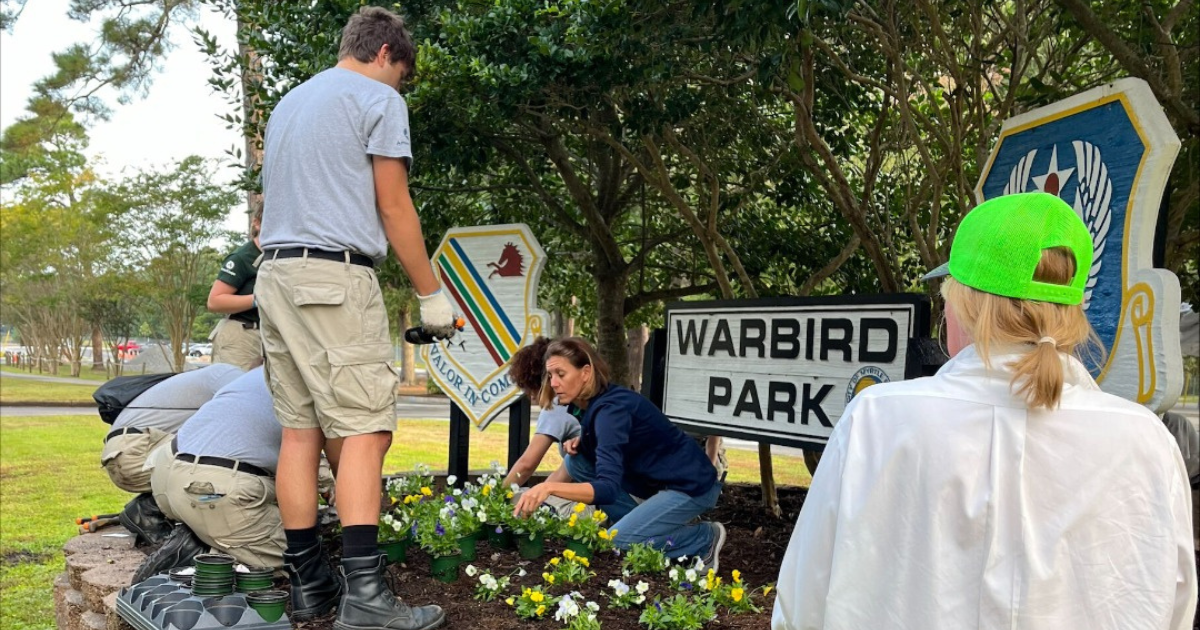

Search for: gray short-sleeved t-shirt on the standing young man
xmin=260 ymin=67 xmax=413 ymax=262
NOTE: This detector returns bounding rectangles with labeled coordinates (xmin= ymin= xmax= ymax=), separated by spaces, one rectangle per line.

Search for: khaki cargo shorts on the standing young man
xmin=254 ymin=253 xmax=400 ymax=438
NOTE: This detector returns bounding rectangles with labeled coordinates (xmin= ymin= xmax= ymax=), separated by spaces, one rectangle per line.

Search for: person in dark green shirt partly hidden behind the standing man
xmin=208 ymin=209 xmax=263 ymax=370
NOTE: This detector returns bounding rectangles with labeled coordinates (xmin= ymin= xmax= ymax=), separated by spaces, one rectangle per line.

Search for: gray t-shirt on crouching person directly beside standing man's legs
xmin=178 ymin=367 xmax=283 ymax=473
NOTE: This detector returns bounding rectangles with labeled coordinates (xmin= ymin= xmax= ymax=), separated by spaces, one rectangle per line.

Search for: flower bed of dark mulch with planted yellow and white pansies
xmin=298 ymin=475 xmax=804 ymax=630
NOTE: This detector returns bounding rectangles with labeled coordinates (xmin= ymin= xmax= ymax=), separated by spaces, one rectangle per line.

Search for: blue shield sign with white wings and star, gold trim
xmin=976 ymin=79 xmax=1183 ymax=412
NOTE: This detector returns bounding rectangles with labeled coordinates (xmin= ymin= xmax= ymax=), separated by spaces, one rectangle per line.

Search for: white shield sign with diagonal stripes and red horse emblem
xmin=421 ymin=224 xmax=548 ymax=431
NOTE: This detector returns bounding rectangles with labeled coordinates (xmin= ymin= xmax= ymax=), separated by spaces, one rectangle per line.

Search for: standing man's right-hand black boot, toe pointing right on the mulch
xmin=334 ymin=553 xmax=446 ymax=630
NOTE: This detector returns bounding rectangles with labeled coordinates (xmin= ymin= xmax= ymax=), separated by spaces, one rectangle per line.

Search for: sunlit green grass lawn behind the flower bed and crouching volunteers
xmin=0 ymin=412 xmax=810 ymax=630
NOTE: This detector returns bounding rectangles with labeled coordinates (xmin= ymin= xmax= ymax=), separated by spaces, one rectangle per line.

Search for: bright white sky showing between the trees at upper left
xmin=0 ymin=0 xmax=246 ymax=232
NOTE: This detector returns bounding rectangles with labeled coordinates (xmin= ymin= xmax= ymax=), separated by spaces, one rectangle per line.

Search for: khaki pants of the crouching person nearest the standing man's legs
xmin=167 ymin=460 xmax=287 ymax=569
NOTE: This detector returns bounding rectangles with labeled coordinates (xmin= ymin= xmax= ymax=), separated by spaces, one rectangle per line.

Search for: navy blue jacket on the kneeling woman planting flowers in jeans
xmin=571 ymin=385 xmax=716 ymax=505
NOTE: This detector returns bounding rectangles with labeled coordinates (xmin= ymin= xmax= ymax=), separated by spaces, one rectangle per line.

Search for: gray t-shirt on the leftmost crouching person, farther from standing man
xmin=113 ymin=364 xmax=244 ymax=433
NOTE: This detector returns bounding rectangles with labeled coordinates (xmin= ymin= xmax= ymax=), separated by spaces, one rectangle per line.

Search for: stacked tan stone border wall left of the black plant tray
xmin=54 ymin=526 xmax=146 ymax=630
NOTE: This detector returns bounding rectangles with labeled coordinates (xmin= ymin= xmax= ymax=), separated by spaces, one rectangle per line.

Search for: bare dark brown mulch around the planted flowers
xmin=284 ymin=484 xmax=805 ymax=630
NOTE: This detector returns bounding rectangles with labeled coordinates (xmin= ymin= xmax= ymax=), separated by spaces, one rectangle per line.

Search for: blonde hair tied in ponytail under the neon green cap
xmin=942 ymin=247 xmax=1098 ymax=409
